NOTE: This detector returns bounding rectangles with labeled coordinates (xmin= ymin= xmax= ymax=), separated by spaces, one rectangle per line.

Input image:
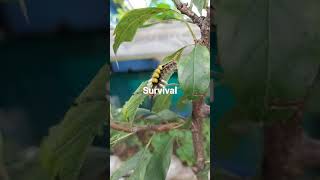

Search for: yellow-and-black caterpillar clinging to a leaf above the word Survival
xmin=148 ymin=61 xmax=177 ymax=89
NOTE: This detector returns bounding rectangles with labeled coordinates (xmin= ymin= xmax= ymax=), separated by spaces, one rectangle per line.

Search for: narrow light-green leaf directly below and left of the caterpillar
xmin=122 ymin=81 xmax=148 ymax=122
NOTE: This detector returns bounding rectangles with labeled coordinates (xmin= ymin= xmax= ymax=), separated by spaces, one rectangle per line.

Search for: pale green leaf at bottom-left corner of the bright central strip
xmin=111 ymin=149 xmax=151 ymax=180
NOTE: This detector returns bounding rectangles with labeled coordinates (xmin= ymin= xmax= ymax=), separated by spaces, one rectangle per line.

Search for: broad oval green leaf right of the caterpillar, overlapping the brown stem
xmin=178 ymin=45 xmax=210 ymax=99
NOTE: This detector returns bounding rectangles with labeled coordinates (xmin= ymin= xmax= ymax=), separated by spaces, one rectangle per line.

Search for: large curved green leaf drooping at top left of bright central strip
xmin=113 ymin=7 xmax=172 ymax=53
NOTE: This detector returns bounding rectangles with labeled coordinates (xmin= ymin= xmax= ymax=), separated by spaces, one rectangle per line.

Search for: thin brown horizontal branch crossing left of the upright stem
xmin=110 ymin=121 xmax=184 ymax=133
